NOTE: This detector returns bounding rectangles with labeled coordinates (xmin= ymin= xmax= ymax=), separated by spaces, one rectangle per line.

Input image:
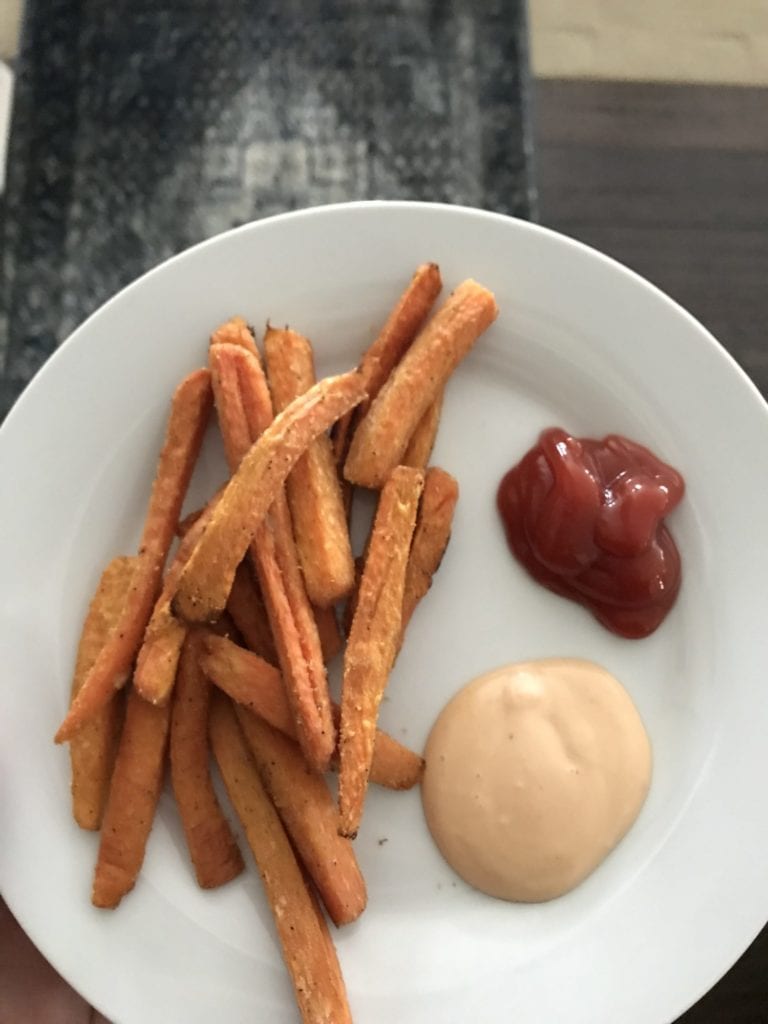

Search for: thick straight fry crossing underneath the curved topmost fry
xmin=264 ymin=327 xmax=354 ymax=608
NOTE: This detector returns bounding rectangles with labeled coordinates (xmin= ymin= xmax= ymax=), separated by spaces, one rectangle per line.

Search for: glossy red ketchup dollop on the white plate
xmin=498 ymin=427 xmax=685 ymax=638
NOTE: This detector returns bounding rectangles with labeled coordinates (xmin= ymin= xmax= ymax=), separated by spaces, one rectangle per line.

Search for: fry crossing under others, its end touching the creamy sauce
xmin=201 ymin=634 xmax=424 ymax=790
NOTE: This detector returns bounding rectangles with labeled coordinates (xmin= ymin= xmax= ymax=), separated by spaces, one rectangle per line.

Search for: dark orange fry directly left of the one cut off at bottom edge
xmin=170 ymin=632 xmax=245 ymax=889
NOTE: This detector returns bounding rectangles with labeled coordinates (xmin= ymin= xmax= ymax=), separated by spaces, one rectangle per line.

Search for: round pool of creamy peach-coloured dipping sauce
xmin=422 ymin=658 xmax=651 ymax=902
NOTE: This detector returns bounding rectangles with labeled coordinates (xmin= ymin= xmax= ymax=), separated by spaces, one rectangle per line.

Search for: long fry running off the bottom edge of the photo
xmin=210 ymin=694 xmax=351 ymax=1024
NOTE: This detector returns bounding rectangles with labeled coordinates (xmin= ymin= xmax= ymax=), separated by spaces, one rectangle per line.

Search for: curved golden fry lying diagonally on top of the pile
xmin=173 ymin=368 xmax=365 ymax=622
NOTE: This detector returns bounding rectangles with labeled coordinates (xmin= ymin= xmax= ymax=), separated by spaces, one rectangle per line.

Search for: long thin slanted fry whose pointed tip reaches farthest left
xmin=55 ymin=370 xmax=213 ymax=743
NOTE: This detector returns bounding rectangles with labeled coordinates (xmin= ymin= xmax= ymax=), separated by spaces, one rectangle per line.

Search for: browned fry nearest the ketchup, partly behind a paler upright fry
xmin=400 ymin=466 xmax=459 ymax=644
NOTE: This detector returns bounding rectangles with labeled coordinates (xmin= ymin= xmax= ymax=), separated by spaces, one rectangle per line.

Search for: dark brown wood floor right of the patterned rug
xmin=535 ymin=81 xmax=768 ymax=1024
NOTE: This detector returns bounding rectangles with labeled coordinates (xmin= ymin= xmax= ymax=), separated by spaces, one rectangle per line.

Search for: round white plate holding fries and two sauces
xmin=0 ymin=203 xmax=768 ymax=1024
